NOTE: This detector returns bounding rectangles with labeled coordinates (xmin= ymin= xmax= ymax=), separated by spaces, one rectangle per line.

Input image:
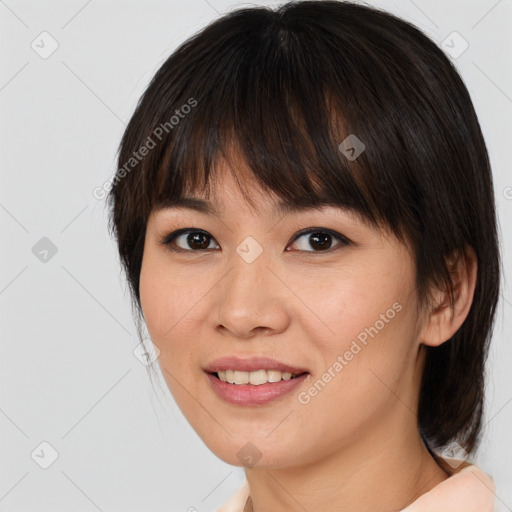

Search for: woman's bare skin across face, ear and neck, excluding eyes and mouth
xmin=140 ymin=158 xmax=476 ymax=512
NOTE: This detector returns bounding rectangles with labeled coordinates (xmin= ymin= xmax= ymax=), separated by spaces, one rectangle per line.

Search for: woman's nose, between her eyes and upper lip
xmin=211 ymin=244 xmax=291 ymax=339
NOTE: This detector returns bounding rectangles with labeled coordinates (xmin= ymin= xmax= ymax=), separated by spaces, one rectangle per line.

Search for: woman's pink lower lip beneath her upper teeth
xmin=206 ymin=373 xmax=309 ymax=405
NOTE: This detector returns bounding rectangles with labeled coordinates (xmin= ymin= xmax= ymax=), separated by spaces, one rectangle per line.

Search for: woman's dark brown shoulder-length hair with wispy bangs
xmin=108 ymin=0 xmax=500 ymax=452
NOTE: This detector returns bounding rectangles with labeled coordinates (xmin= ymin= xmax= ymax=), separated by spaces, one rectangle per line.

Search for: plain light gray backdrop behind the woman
xmin=0 ymin=0 xmax=512 ymax=512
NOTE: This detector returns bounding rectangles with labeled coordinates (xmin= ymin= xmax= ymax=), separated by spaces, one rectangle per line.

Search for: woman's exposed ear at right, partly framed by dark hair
xmin=420 ymin=246 xmax=478 ymax=347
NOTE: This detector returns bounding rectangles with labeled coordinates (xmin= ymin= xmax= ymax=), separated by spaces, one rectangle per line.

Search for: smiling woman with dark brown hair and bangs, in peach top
xmin=109 ymin=1 xmax=500 ymax=512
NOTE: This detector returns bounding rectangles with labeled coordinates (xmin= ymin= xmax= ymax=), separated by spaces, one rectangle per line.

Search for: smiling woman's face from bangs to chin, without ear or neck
xmin=140 ymin=162 xmax=423 ymax=467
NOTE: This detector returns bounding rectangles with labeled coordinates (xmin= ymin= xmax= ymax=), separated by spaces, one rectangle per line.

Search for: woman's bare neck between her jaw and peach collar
xmin=244 ymin=411 xmax=448 ymax=512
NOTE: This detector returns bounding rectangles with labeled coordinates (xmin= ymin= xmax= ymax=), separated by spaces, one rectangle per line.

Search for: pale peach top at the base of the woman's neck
xmin=217 ymin=459 xmax=496 ymax=512
